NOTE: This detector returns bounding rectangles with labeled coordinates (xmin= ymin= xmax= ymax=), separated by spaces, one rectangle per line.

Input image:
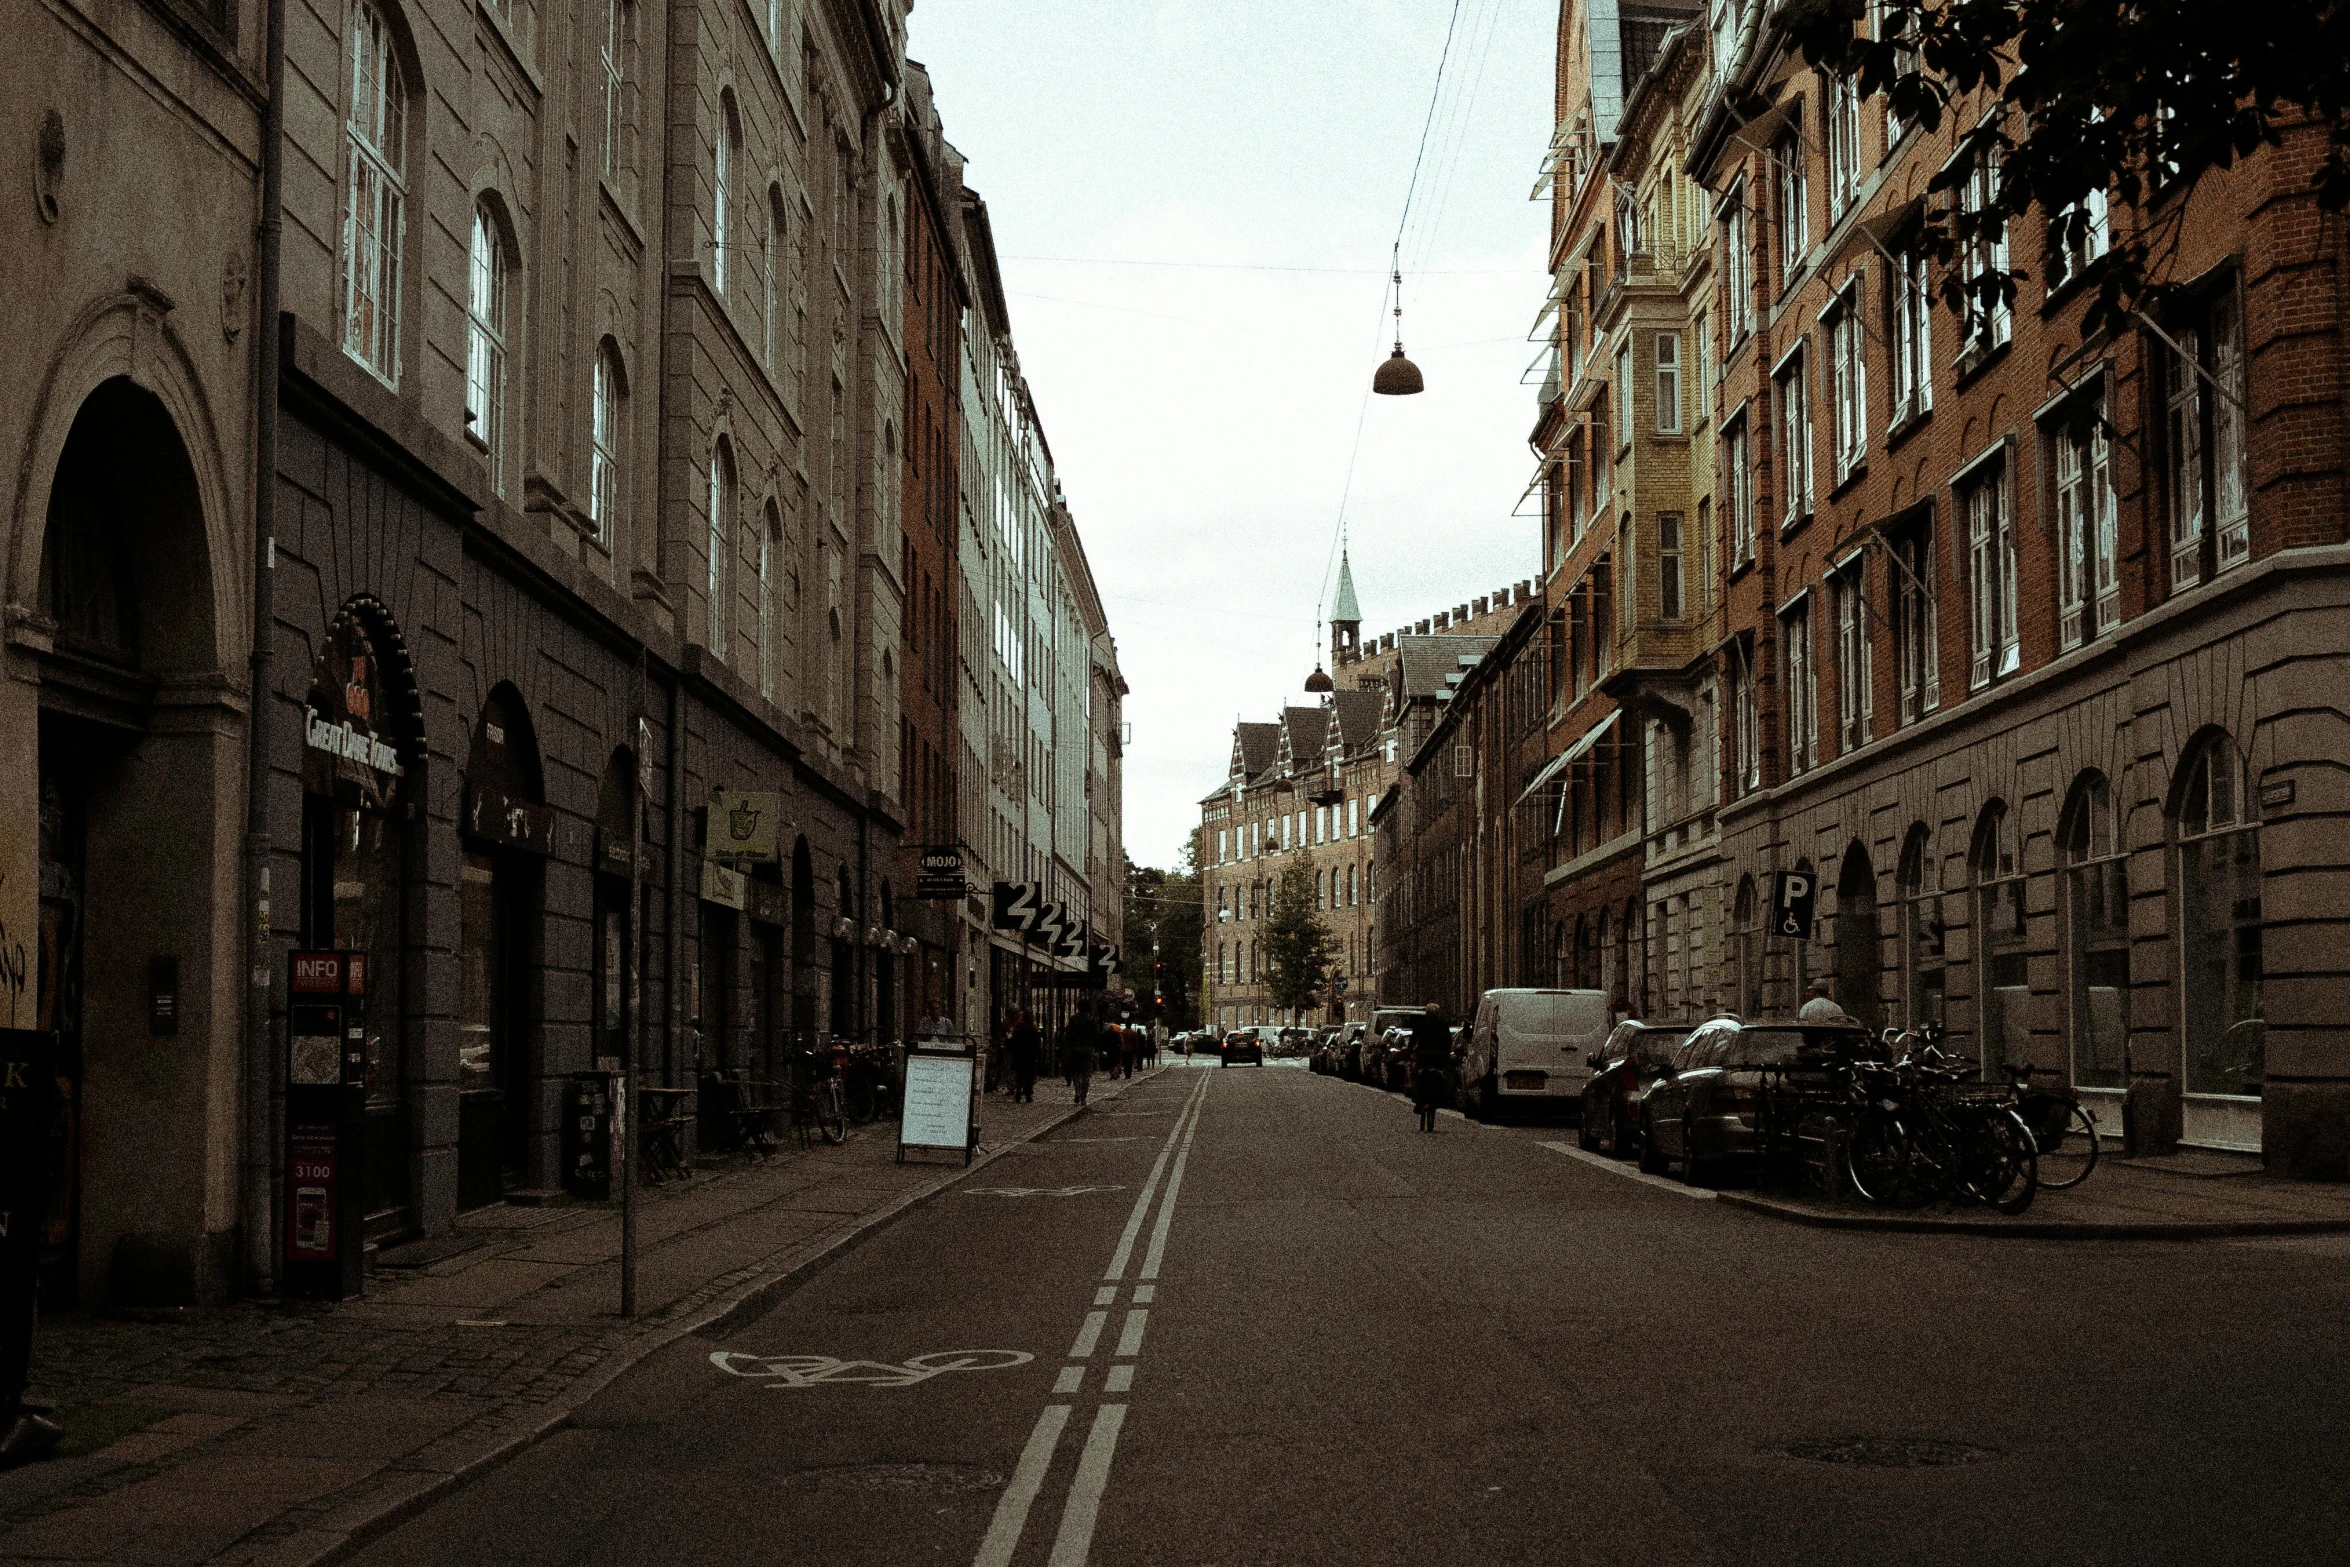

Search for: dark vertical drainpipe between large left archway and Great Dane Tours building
xmin=244 ymin=0 xmax=287 ymax=1294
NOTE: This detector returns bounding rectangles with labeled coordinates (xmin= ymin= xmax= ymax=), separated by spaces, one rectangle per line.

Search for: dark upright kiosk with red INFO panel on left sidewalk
xmin=284 ymin=951 xmax=367 ymax=1302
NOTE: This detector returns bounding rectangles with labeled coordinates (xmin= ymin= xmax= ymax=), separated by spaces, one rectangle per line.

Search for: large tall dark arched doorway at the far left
xmin=30 ymin=378 xmax=226 ymax=1309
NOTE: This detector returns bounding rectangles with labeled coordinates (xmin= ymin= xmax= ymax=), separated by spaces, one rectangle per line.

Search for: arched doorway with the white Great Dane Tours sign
xmin=301 ymin=599 xmax=423 ymax=1238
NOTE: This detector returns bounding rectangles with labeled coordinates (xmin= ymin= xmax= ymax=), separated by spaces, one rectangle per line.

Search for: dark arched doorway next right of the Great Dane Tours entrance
xmin=456 ymin=684 xmax=555 ymax=1208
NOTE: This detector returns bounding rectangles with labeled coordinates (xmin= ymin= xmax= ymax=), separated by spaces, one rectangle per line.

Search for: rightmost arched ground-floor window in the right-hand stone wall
xmin=2171 ymin=733 xmax=2268 ymax=1108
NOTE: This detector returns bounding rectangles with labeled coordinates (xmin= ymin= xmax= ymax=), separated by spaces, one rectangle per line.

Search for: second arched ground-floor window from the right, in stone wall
xmin=2056 ymin=773 xmax=2129 ymax=1088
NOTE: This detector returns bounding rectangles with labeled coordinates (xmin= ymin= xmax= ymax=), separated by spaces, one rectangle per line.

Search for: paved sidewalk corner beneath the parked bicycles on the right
xmin=1716 ymin=1151 xmax=2350 ymax=1240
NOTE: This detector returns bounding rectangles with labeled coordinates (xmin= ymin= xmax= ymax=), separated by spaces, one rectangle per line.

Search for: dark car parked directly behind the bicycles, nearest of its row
xmin=1640 ymin=1017 xmax=1887 ymax=1186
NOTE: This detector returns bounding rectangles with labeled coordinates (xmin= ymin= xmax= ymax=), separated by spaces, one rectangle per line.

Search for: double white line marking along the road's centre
xmin=971 ymin=1076 xmax=1215 ymax=1567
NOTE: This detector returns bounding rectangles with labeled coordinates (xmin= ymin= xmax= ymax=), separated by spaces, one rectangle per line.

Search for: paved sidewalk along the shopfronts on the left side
xmin=0 ymin=1076 xmax=1144 ymax=1567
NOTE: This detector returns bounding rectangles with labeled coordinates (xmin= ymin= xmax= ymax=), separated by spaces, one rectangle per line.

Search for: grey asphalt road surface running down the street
xmin=343 ymin=1067 xmax=2350 ymax=1567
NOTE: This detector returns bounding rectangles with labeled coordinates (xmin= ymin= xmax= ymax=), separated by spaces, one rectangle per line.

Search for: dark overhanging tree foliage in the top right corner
xmin=1791 ymin=0 xmax=2350 ymax=334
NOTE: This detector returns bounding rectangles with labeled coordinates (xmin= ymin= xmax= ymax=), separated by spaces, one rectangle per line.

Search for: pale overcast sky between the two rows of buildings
xmin=907 ymin=0 xmax=1558 ymax=867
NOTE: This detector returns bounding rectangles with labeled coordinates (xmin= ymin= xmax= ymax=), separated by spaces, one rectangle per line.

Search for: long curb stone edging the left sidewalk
xmin=212 ymin=1067 xmax=1166 ymax=1567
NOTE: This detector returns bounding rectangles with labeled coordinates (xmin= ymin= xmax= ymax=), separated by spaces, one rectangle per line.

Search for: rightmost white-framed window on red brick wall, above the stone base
xmin=2150 ymin=282 xmax=2251 ymax=590
